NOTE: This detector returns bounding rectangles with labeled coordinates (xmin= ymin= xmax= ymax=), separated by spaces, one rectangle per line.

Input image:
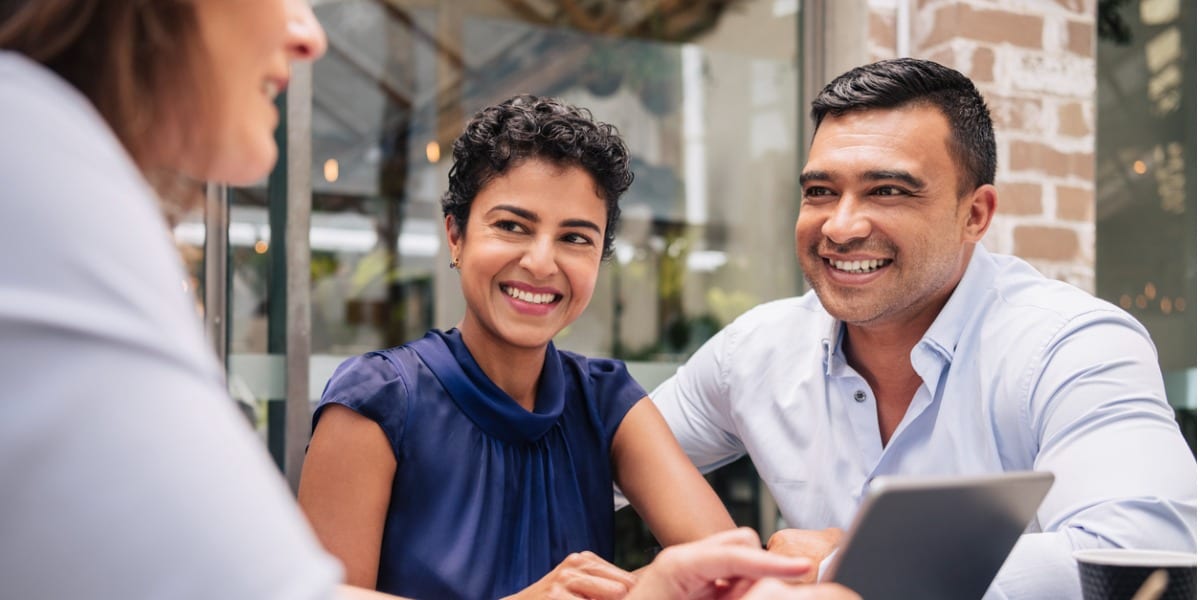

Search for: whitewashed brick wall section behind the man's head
xmin=865 ymin=0 xmax=1096 ymax=292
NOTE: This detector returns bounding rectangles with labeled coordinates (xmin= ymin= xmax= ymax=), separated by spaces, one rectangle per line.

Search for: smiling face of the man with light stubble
xmin=796 ymin=106 xmax=995 ymax=330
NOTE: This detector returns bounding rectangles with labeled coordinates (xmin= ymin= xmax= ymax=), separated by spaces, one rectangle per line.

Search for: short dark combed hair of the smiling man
xmin=812 ymin=59 xmax=996 ymax=193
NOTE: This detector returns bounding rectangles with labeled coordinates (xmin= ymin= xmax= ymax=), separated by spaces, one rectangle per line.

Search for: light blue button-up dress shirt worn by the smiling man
xmin=652 ymin=246 xmax=1196 ymax=599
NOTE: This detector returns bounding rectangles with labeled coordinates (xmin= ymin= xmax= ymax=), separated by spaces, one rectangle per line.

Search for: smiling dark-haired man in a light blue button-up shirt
xmin=652 ymin=59 xmax=1196 ymax=598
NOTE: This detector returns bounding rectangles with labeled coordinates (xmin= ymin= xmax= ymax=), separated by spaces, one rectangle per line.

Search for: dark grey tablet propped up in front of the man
xmin=826 ymin=472 xmax=1054 ymax=600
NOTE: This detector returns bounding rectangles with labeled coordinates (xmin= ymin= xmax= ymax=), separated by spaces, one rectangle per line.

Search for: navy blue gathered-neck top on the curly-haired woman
xmin=313 ymin=329 xmax=646 ymax=599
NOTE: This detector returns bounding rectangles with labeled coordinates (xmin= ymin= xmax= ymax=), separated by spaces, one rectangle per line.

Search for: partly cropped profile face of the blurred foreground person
xmin=182 ymin=0 xmax=325 ymax=185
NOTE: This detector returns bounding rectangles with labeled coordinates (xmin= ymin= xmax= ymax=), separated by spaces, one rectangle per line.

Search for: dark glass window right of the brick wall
xmin=1096 ymin=0 xmax=1196 ymax=451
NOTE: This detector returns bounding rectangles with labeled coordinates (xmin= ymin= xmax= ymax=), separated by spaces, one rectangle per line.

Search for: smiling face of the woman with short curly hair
xmin=446 ymin=160 xmax=607 ymax=356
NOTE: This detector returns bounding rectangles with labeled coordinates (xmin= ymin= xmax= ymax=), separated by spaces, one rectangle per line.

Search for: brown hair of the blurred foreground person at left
xmin=0 ymin=0 xmax=206 ymax=176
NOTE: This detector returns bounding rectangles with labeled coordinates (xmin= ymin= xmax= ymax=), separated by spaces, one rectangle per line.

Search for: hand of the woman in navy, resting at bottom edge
xmin=509 ymin=552 xmax=637 ymax=600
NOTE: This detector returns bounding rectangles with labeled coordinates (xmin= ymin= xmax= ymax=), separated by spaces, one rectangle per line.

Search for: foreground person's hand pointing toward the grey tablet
xmin=628 ymin=528 xmax=811 ymax=600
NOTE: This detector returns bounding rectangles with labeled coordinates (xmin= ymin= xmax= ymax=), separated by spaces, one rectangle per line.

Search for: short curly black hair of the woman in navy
xmin=442 ymin=95 xmax=634 ymax=258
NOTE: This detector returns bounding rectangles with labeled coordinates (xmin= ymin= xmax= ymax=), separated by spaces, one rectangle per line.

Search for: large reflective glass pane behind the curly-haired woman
xmin=304 ymin=0 xmax=802 ymax=361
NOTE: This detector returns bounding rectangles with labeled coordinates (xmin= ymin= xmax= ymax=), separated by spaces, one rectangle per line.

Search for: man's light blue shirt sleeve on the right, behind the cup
xmin=989 ymin=310 xmax=1196 ymax=598
